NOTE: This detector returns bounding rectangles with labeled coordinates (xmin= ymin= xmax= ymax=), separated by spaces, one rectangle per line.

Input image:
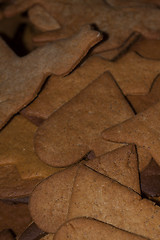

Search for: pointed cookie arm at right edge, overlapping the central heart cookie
xmin=102 ymin=102 xmax=160 ymax=165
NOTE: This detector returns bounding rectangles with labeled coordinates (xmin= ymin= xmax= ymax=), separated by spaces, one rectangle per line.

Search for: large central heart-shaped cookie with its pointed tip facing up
xmin=35 ymin=72 xmax=133 ymax=167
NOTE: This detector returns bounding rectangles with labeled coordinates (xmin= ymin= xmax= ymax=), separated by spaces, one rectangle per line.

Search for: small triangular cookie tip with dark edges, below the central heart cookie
xmin=84 ymin=145 xmax=141 ymax=193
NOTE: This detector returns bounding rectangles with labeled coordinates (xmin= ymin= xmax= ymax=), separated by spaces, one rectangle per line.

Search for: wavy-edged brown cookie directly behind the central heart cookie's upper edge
xmin=22 ymin=52 xmax=159 ymax=125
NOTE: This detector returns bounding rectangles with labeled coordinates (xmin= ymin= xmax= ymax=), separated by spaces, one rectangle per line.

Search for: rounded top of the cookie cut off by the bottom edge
xmin=54 ymin=218 xmax=147 ymax=240
